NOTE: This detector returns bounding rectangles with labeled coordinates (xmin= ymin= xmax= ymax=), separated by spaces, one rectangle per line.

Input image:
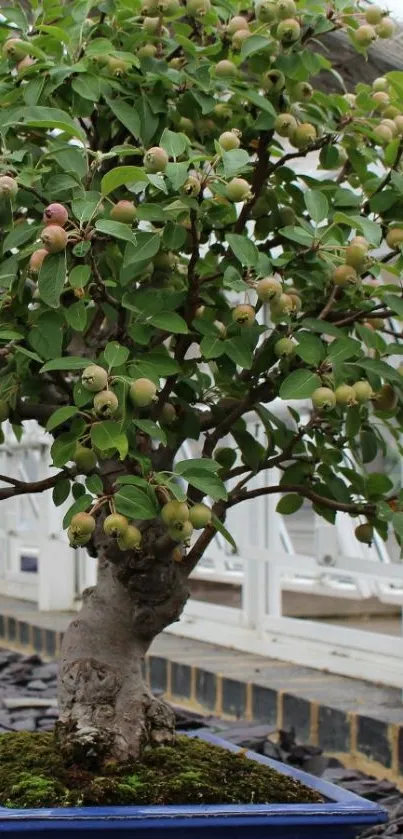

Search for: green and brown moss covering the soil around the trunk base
xmin=0 ymin=732 xmax=323 ymax=808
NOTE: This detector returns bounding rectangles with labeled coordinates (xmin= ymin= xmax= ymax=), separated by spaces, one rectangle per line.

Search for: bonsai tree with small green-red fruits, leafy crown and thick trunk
xmin=0 ymin=0 xmax=403 ymax=761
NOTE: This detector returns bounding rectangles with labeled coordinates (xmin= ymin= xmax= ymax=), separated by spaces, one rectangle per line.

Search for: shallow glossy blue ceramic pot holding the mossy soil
xmin=0 ymin=731 xmax=387 ymax=839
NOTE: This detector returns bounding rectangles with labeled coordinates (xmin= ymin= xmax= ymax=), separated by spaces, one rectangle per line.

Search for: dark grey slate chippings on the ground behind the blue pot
xmin=0 ymin=650 xmax=403 ymax=839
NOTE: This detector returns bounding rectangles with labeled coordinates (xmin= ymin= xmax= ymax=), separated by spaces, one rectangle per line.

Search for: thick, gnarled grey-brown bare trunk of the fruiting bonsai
xmin=56 ymin=528 xmax=188 ymax=766
